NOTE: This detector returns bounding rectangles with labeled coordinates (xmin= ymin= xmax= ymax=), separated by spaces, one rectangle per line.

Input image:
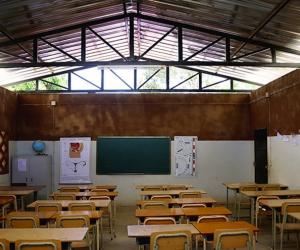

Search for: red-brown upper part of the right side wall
xmin=250 ymin=69 xmax=300 ymax=136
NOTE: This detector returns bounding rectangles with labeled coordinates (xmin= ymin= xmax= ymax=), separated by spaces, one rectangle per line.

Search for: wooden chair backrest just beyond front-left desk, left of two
xmin=6 ymin=215 xmax=40 ymax=228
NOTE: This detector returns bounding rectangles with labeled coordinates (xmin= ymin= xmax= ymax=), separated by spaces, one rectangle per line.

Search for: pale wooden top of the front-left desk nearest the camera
xmin=0 ymin=227 xmax=88 ymax=242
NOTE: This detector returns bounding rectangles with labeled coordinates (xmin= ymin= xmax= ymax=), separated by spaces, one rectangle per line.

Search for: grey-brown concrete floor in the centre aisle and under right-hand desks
xmin=103 ymin=206 xmax=297 ymax=250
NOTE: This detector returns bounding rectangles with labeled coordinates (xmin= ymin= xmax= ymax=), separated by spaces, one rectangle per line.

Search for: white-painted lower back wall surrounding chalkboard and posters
xmin=15 ymin=141 xmax=254 ymax=205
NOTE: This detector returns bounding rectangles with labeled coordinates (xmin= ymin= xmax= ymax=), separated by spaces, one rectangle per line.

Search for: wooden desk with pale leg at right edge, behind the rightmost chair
xmin=259 ymin=199 xmax=300 ymax=250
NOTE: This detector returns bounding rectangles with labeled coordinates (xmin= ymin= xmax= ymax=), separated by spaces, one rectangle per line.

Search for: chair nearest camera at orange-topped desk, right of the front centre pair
xmin=213 ymin=229 xmax=253 ymax=250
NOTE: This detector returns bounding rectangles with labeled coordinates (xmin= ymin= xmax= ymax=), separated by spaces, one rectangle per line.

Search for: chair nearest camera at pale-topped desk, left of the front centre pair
xmin=150 ymin=231 xmax=192 ymax=250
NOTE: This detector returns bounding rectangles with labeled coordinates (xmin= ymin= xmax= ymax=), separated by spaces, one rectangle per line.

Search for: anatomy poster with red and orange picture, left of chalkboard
xmin=60 ymin=137 xmax=91 ymax=183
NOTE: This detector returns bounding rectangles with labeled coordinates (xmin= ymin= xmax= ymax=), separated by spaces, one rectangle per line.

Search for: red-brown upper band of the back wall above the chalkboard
xmin=17 ymin=93 xmax=251 ymax=140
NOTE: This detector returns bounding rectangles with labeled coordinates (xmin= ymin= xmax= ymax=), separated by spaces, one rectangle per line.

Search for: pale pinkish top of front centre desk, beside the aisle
xmin=127 ymin=224 xmax=199 ymax=238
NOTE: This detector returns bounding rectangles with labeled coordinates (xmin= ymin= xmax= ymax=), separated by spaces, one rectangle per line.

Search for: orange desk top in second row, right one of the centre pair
xmin=182 ymin=207 xmax=232 ymax=216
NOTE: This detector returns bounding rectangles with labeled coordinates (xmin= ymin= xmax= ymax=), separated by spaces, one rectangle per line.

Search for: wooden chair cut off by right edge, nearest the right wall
xmin=274 ymin=202 xmax=300 ymax=250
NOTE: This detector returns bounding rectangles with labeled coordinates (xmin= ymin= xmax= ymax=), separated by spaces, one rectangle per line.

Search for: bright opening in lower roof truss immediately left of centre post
xmin=104 ymin=68 xmax=133 ymax=90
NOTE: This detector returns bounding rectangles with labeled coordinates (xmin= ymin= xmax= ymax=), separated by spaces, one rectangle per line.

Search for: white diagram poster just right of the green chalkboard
xmin=174 ymin=136 xmax=197 ymax=176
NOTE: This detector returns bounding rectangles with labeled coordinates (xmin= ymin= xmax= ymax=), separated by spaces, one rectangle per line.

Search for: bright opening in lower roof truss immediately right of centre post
xmin=137 ymin=67 xmax=166 ymax=89
